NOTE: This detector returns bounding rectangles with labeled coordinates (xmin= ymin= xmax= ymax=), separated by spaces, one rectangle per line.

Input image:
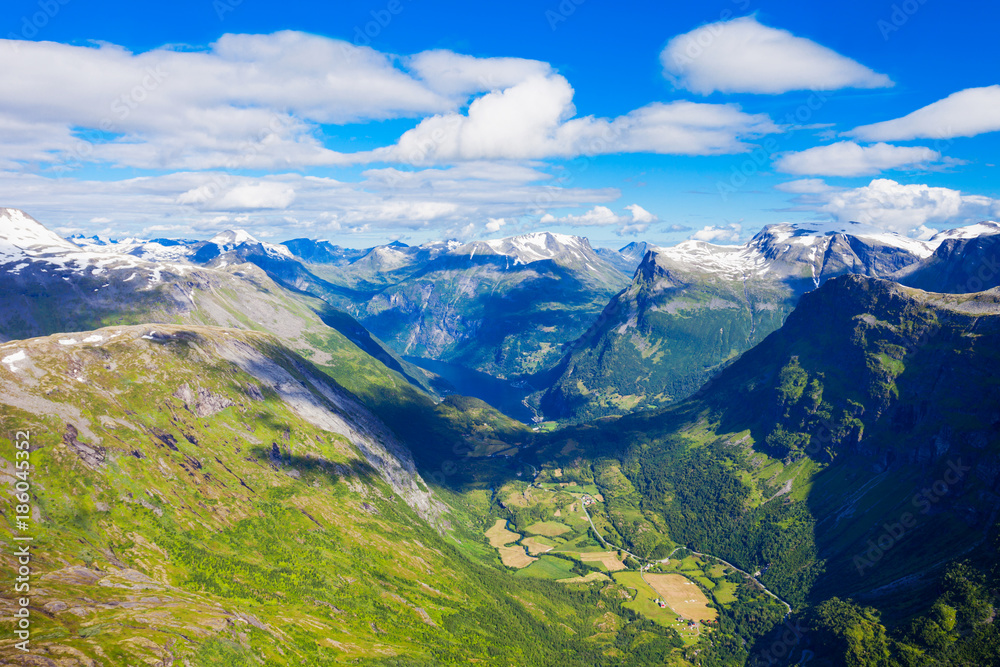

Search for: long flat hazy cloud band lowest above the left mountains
xmin=0 ymin=164 xmax=624 ymax=239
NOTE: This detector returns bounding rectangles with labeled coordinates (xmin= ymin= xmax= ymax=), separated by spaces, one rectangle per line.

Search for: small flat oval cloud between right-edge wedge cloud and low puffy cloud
xmin=774 ymin=141 xmax=941 ymax=176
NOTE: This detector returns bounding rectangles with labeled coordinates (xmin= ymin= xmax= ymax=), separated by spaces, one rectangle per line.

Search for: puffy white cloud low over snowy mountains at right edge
xmin=795 ymin=178 xmax=1000 ymax=236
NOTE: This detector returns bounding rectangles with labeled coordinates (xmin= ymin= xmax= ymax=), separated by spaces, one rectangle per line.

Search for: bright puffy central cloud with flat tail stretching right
xmin=368 ymin=74 xmax=780 ymax=164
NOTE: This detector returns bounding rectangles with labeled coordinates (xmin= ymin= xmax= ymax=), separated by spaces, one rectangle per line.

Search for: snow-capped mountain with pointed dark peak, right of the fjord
xmin=543 ymin=222 xmax=1000 ymax=417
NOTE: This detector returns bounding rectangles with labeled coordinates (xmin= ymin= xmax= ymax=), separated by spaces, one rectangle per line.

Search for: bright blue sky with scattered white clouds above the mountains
xmin=0 ymin=0 xmax=1000 ymax=246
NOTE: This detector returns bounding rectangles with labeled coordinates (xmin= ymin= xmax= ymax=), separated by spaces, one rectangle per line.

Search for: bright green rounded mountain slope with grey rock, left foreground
xmin=0 ymin=325 xmax=677 ymax=666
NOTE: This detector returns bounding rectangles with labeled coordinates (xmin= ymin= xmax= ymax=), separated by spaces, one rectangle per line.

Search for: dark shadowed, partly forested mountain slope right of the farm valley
xmin=520 ymin=276 xmax=1000 ymax=664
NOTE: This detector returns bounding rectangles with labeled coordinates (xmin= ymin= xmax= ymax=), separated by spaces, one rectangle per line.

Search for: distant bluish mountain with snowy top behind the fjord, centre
xmin=299 ymin=233 xmax=627 ymax=378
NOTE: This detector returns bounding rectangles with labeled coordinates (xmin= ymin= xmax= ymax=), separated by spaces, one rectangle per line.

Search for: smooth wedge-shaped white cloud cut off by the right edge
xmin=846 ymin=85 xmax=1000 ymax=141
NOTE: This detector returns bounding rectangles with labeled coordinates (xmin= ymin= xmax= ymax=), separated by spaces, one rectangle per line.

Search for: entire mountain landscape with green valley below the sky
xmin=0 ymin=209 xmax=1000 ymax=667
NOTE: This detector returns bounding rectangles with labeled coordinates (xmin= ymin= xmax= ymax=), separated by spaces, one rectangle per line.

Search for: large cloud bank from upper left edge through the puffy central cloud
xmin=0 ymin=31 xmax=778 ymax=170
